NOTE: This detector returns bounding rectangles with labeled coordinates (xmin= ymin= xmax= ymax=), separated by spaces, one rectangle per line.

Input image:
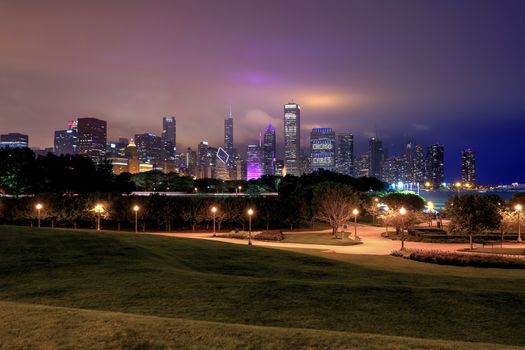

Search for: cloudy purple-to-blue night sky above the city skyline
xmin=0 ymin=0 xmax=525 ymax=183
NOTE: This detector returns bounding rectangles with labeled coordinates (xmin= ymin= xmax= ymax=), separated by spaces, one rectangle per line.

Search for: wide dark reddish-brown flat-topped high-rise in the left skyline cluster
xmin=77 ymin=117 xmax=107 ymax=162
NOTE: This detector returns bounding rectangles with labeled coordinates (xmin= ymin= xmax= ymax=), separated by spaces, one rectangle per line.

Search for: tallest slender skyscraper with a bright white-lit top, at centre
xmin=284 ymin=102 xmax=301 ymax=176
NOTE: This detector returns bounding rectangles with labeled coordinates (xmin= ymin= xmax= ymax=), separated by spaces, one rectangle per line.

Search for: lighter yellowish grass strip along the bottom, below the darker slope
xmin=0 ymin=302 xmax=520 ymax=350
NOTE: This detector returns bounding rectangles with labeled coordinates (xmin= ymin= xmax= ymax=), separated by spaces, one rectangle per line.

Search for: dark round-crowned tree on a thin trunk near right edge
xmin=445 ymin=194 xmax=501 ymax=249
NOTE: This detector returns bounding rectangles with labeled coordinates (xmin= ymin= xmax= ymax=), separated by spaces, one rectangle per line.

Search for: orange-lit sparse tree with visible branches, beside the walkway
xmin=313 ymin=182 xmax=361 ymax=238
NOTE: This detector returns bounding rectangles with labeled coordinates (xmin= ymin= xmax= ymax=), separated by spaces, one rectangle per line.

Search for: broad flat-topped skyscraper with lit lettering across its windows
xmin=310 ymin=128 xmax=335 ymax=171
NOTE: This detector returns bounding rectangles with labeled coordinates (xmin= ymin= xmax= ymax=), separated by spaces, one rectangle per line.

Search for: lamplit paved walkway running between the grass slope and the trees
xmin=141 ymin=225 xmax=523 ymax=255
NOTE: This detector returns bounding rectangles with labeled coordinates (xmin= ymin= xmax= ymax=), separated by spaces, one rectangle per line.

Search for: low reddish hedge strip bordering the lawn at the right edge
xmin=390 ymin=249 xmax=525 ymax=269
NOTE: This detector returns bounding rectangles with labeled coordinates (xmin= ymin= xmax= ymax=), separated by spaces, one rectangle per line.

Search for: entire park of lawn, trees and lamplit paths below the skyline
xmin=0 ymin=155 xmax=525 ymax=349
